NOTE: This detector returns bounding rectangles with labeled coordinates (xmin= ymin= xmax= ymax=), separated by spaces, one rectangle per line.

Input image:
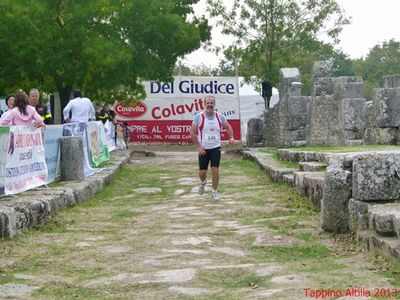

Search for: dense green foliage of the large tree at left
xmin=0 ymin=0 xmax=210 ymax=110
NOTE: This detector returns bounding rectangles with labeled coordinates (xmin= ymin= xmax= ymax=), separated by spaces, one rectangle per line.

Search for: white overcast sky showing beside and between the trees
xmin=184 ymin=0 xmax=400 ymax=67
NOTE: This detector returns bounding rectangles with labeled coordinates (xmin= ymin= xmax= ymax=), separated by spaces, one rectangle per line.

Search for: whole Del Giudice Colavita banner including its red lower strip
xmin=114 ymin=77 xmax=240 ymax=142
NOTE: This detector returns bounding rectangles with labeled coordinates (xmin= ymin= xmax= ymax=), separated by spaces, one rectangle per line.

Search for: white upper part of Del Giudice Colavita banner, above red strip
xmin=114 ymin=76 xmax=239 ymax=121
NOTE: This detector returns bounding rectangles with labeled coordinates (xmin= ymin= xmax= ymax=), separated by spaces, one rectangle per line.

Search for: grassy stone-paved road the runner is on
xmin=0 ymin=152 xmax=392 ymax=299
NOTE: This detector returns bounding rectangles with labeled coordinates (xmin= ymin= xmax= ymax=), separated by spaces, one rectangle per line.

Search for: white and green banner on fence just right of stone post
xmin=86 ymin=121 xmax=110 ymax=167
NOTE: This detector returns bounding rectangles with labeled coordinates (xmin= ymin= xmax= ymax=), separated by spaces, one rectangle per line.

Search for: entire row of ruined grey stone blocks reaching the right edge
xmin=249 ymin=60 xmax=400 ymax=147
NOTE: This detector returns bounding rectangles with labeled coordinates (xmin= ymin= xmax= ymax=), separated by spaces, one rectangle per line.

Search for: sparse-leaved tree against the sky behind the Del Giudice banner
xmin=207 ymin=0 xmax=349 ymax=106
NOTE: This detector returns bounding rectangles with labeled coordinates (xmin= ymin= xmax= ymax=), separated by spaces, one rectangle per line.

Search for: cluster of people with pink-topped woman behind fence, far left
xmin=0 ymin=89 xmax=53 ymax=127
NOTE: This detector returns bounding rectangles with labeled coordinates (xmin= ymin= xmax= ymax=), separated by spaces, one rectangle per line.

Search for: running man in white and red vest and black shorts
xmin=190 ymin=96 xmax=235 ymax=201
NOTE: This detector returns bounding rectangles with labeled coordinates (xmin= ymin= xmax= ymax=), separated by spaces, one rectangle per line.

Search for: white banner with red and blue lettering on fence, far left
xmin=4 ymin=125 xmax=47 ymax=195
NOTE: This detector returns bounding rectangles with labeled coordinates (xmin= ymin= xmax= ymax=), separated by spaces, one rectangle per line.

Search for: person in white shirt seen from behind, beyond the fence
xmin=63 ymin=90 xmax=96 ymax=123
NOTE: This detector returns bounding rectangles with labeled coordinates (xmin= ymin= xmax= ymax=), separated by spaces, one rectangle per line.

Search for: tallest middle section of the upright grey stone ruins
xmin=307 ymin=61 xmax=365 ymax=146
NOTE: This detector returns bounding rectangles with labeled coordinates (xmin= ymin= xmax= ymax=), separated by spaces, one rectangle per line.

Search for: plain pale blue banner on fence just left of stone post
xmin=44 ymin=125 xmax=63 ymax=183
